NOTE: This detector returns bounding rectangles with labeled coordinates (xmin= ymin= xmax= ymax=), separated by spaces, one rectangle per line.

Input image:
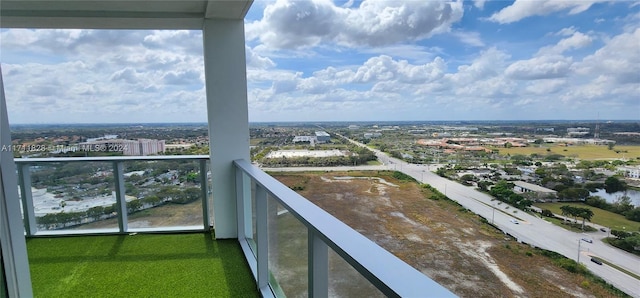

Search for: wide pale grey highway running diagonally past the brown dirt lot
xmin=336 ymin=139 xmax=640 ymax=298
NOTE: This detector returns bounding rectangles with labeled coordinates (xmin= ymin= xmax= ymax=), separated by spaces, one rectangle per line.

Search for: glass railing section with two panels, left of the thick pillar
xmin=15 ymin=155 xmax=213 ymax=236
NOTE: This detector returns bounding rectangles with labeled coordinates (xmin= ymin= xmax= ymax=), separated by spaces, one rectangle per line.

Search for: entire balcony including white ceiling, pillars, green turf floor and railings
xmin=0 ymin=0 xmax=453 ymax=297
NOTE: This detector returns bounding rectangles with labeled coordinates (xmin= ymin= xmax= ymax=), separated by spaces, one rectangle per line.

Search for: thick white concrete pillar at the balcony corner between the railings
xmin=202 ymin=19 xmax=249 ymax=239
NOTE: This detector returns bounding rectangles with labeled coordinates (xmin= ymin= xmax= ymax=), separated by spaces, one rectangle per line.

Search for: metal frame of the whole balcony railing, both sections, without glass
xmin=15 ymin=155 xmax=455 ymax=297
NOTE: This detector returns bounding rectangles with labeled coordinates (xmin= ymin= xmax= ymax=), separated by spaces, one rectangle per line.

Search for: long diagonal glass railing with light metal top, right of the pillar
xmin=234 ymin=160 xmax=455 ymax=297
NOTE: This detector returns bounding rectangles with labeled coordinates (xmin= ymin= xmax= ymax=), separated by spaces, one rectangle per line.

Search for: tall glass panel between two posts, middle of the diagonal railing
xmin=267 ymin=196 xmax=308 ymax=297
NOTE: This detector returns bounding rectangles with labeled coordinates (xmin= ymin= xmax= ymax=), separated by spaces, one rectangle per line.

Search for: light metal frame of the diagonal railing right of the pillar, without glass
xmin=234 ymin=160 xmax=455 ymax=297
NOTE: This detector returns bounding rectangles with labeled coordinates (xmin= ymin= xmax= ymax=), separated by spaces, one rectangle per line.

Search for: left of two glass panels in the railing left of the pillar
xmin=29 ymin=162 xmax=118 ymax=231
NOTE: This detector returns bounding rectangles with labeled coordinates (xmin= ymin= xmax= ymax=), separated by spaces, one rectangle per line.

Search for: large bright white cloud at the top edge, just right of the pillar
xmin=247 ymin=0 xmax=463 ymax=48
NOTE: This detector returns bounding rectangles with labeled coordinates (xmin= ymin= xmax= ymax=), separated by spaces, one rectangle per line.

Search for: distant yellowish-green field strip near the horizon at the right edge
xmin=499 ymin=144 xmax=640 ymax=160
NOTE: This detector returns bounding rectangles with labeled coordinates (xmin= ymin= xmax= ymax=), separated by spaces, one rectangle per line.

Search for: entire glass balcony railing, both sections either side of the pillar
xmin=15 ymin=155 xmax=454 ymax=297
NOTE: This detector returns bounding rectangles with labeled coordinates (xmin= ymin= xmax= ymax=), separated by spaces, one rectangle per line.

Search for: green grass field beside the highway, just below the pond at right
xmin=535 ymin=202 xmax=640 ymax=231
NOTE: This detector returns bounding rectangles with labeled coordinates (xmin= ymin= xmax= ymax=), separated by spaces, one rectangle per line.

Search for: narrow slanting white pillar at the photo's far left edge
xmin=0 ymin=68 xmax=33 ymax=297
